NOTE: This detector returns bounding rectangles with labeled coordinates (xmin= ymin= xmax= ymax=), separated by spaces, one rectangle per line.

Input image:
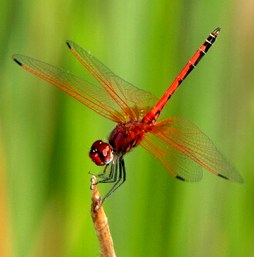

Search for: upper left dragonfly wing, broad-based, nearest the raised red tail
xmin=67 ymin=41 xmax=158 ymax=121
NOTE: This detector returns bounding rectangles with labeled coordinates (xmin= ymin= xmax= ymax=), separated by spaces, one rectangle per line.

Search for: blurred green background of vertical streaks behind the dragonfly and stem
xmin=0 ymin=0 xmax=254 ymax=257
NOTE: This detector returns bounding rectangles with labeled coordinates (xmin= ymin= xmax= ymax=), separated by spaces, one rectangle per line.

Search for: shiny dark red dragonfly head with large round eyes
xmin=89 ymin=140 xmax=114 ymax=166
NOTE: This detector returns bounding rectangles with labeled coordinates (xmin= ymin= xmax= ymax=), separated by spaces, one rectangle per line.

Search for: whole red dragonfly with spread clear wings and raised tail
xmin=13 ymin=28 xmax=243 ymax=201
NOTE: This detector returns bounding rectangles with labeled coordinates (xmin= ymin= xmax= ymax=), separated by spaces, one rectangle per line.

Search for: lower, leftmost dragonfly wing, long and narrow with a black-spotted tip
xmin=13 ymin=55 xmax=133 ymax=122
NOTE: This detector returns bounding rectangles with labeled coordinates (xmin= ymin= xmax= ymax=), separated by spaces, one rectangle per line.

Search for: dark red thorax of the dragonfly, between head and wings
xmin=109 ymin=121 xmax=147 ymax=155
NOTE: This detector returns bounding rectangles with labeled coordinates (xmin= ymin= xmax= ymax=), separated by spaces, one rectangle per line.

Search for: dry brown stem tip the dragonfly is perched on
xmin=91 ymin=176 xmax=116 ymax=257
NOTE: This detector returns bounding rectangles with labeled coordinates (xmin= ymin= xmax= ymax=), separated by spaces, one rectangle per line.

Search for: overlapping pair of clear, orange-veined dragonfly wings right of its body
xmin=141 ymin=117 xmax=243 ymax=183
